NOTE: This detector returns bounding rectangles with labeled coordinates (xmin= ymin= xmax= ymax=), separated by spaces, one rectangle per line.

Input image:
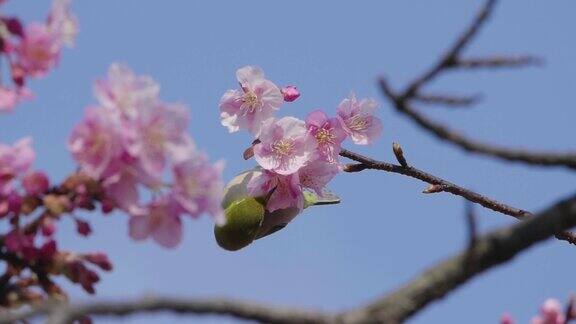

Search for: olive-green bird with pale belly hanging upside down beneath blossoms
xmin=214 ymin=168 xmax=340 ymax=251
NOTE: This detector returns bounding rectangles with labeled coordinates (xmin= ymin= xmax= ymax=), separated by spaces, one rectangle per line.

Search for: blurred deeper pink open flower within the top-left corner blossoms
xmin=16 ymin=23 xmax=61 ymax=77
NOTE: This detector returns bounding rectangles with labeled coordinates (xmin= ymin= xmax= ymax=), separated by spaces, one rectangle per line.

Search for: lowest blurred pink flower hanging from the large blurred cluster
xmin=129 ymin=197 xmax=182 ymax=248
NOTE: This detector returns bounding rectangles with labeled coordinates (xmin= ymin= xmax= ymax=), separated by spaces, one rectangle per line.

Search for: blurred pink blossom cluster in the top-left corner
xmin=0 ymin=0 xmax=78 ymax=112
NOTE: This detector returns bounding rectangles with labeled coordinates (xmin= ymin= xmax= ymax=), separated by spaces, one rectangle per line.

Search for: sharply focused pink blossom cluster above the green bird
xmin=220 ymin=66 xmax=382 ymax=212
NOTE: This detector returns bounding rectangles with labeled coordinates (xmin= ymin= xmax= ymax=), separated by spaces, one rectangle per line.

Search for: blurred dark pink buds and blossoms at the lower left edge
xmin=0 ymin=138 xmax=112 ymax=296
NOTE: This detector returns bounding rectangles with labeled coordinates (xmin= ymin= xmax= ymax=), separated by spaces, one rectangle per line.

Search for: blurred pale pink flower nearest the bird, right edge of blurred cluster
xmin=172 ymin=153 xmax=225 ymax=224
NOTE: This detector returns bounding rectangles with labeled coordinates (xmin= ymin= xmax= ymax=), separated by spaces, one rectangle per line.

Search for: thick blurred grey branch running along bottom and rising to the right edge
xmin=6 ymin=195 xmax=576 ymax=324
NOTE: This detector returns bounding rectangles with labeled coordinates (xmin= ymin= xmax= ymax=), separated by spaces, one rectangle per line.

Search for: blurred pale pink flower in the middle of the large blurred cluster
xmin=128 ymin=103 xmax=189 ymax=179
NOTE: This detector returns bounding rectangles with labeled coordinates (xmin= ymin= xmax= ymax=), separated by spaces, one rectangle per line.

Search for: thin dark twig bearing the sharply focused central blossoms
xmin=340 ymin=149 xmax=576 ymax=244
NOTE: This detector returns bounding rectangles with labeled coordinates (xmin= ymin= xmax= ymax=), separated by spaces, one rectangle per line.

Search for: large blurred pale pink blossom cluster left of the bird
xmin=68 ymin=64 xmax=224 ymax=248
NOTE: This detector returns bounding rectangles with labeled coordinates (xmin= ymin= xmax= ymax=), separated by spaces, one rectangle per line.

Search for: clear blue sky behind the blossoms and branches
xmin=0 ymin=0 xmax=576 ymax=323
